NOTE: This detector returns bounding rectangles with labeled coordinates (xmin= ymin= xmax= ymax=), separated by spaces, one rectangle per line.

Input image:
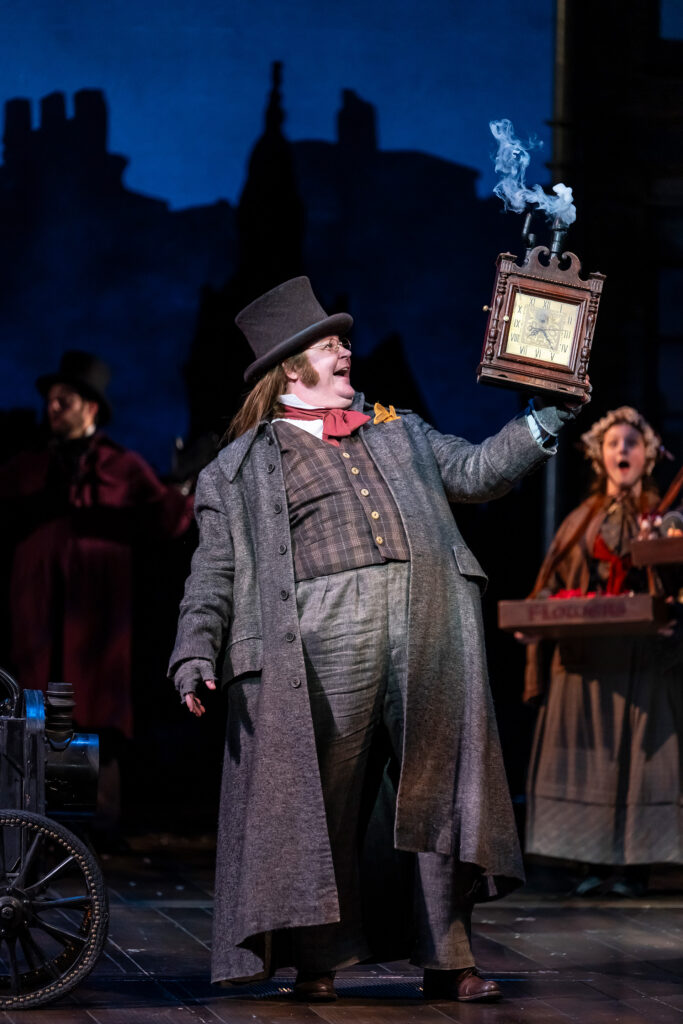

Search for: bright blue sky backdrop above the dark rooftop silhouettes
xmin=0 ymin=0 xmax=554 ymax=207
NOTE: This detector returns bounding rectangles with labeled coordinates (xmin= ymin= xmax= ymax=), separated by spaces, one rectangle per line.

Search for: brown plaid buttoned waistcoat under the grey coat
xmin=273 ymin=421 xmax=410 ymax=581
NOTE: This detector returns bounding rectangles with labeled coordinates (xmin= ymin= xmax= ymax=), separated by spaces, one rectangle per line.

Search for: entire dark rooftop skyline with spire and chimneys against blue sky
xmin=0 ymin=61 xmax=532 ymax=471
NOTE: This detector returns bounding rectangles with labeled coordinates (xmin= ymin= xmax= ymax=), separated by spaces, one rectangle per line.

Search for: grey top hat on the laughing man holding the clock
xmin=234 ymin=278 xmax=353 ymax=384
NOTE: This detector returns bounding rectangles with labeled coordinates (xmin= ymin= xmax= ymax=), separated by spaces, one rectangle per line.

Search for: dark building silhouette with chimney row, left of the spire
xmin=0 ymin=89 xmax=237 ymax=469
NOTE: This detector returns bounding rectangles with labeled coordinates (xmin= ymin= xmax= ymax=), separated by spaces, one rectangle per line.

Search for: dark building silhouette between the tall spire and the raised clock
xmin=294 ymin=89 xmax=521 ymax=438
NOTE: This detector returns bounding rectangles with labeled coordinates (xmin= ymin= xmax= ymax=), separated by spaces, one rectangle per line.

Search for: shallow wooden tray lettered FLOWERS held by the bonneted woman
xmin=498 ymin=594 xmax=670 ymax=638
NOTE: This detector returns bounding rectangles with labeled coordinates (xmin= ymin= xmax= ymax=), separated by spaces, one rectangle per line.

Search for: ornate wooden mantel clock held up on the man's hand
xmin=477 ymin=245 xmax=605 ymax=398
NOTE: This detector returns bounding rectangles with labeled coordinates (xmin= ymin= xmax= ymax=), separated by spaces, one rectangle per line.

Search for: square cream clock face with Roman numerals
xmin=505 ymin=291 xmax=580 ymax=367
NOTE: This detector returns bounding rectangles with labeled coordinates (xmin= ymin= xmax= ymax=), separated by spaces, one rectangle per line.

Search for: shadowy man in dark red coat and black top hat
xmin=0 ymin=351 xmax=193 ymax=839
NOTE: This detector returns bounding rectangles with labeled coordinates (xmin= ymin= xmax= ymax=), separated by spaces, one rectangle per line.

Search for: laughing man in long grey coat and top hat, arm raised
xmin=169 ymin=278 xmax=573 ymax=1000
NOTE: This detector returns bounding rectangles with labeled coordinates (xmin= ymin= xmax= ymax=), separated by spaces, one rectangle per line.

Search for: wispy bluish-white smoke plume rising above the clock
xmin=488 ymin=118 xmax=577 ymax=227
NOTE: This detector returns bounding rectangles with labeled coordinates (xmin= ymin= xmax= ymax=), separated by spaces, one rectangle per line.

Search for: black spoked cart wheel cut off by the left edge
xmin=0 ymin=811 xmax=109 ymax=1010
